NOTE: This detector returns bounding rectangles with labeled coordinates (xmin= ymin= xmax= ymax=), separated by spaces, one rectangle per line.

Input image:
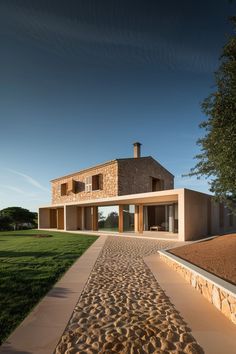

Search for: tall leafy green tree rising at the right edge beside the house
xmin=189 ymin=16 xmax=236 ymax=210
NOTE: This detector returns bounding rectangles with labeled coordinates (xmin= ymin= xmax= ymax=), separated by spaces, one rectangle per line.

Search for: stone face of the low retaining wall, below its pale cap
xmin=159 ymin=252 xmax=236 ymax=324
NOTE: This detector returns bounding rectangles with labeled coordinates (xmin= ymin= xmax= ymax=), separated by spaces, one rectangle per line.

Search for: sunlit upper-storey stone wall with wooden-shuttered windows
xmin=51 ymin=161 xmax=118 ymax=204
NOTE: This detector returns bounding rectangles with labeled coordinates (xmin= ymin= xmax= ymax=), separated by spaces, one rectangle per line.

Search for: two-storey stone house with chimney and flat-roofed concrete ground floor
xmin=39 ymin=142 xmax=236 ymax=240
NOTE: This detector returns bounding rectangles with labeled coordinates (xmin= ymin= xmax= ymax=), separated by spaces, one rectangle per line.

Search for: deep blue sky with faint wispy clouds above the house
xmin=0 ymin=0 xmax=236 ymax=210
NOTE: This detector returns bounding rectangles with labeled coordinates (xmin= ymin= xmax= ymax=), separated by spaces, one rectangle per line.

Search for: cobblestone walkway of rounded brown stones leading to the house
xmin=55 ymin=236 xmax=204 ymax=354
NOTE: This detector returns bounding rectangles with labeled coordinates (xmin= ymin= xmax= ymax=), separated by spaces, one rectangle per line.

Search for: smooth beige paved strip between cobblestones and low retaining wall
xmin=144 ymin=255 xmax=236 ymax=354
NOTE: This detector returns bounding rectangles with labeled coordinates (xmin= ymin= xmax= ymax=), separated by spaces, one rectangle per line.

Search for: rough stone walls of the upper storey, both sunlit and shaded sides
xmin=52 ymin=157 xmax=174 ymax=204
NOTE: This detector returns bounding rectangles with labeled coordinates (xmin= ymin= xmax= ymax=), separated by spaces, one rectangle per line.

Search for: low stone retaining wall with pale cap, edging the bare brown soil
xmin=159 ymin=251 xmax=236 ymax=324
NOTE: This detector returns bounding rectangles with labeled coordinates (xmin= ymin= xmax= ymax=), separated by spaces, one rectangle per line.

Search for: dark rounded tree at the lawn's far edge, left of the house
xmin=0 ymin=207 xmax=37 ymax=230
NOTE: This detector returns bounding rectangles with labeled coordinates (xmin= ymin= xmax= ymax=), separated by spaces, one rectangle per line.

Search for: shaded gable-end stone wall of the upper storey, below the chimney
xmin=118 ymin=157 xmax=174 ymax=195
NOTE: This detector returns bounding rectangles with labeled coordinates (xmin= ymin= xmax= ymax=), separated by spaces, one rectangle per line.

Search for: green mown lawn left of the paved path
xmin=0 ymin=230 xmax=97 ymax=343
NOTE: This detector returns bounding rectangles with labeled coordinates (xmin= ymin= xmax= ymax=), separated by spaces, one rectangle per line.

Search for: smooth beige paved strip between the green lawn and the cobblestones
xmin=0 ymin=236 xmax=107 ymax=354
